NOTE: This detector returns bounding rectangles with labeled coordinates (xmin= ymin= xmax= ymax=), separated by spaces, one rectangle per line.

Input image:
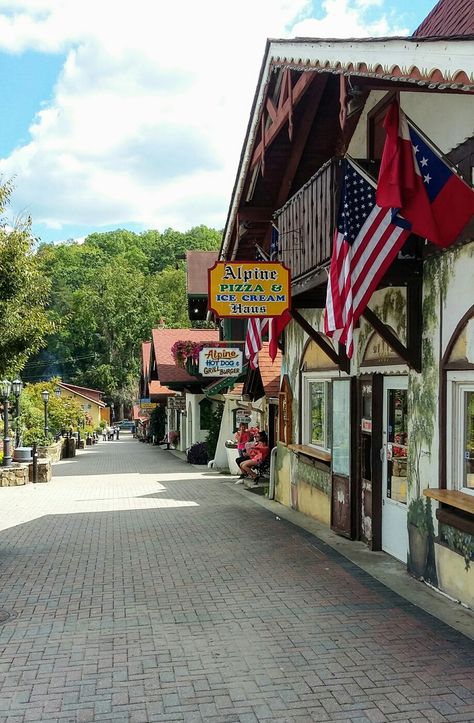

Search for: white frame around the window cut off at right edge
xmin=446 ymin=369 xmax=474 ymax=495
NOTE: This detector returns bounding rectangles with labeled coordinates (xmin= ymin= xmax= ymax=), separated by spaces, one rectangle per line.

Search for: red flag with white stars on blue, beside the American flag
xmin=377 ymin=101 xmax=474 ymax=247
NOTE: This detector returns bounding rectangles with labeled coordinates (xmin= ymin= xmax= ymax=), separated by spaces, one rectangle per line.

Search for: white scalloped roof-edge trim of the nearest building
xmin=219 ymin=36 xmax=474 ymax=260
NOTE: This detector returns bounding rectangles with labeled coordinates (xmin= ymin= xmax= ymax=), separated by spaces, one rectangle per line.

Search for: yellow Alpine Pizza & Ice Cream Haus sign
xmin=208 ymin=261 xmax=291 ymax=317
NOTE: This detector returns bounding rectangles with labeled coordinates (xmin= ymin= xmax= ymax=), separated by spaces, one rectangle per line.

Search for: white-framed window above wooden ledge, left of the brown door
xmin=303 ymin=375 xmax=331 ymax=451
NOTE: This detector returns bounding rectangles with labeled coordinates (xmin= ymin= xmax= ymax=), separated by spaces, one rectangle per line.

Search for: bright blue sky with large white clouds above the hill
xmin=0 ymin=0 xmax=435 ymax=241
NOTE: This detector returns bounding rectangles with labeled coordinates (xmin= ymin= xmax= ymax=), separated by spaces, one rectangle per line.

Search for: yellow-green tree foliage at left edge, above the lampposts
xmin=0 ymin=183 xmax=54 ymax=378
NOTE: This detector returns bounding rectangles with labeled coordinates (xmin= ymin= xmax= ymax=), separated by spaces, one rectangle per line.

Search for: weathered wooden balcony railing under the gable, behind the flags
xmin=275 ymin=159 xmax=339 ymax=279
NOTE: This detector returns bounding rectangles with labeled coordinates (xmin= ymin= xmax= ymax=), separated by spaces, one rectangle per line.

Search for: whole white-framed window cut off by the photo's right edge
xmin=447 ymin=371 xmax=474 ymax=494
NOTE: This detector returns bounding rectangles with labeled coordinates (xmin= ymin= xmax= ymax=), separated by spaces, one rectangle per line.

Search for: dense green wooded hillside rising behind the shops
xmin=25 ymin=226 xmax=221 ymax=404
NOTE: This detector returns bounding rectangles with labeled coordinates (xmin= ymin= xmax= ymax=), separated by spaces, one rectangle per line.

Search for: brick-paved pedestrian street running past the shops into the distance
xmin=0 ymin=436 xmax=474 ymax=723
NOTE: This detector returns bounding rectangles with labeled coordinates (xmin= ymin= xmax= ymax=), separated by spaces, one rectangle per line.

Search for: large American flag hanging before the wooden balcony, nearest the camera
xmin=324 ymin=158 xmax=410 ymax=358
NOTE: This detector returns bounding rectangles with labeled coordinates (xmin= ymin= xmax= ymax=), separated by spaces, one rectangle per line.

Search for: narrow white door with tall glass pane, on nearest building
xmin=381 ymin=377 xmax=408 ymax=563
